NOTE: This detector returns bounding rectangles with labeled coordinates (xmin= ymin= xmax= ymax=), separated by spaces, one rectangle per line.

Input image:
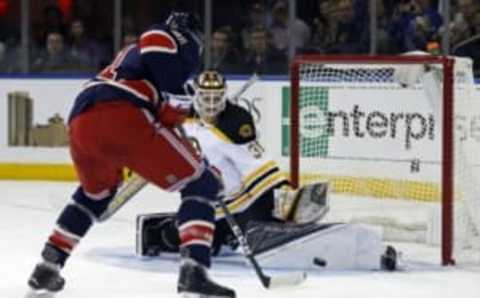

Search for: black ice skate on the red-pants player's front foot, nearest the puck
xmin=177 ymin=258 xmax=235 ymax=298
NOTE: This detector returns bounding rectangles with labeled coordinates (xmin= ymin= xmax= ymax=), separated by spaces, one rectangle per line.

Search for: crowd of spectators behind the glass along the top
xmin=0 ymin=0 xmax=480 ymax=75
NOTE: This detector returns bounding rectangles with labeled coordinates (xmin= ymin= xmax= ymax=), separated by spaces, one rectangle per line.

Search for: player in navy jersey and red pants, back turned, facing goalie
xmin=28 ymin=12 xmax=235 ymax=298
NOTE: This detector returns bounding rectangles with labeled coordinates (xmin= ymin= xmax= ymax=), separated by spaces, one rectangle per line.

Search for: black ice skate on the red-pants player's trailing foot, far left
xmin=26 ymin=262 xmax=65 ymax=298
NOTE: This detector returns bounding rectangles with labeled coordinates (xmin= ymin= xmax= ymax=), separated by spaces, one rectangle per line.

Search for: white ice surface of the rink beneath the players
xmin=0 ymin=181 xmax=480 ymax=298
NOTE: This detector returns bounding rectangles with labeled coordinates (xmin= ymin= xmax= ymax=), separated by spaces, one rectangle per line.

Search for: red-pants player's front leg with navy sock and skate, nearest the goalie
xmin=126 ymin=117 xmax=235 ymax=297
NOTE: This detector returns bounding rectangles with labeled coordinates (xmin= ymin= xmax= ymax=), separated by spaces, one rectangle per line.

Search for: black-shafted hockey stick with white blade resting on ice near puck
xmin=218 ymin=198 xmax=307 ymax=289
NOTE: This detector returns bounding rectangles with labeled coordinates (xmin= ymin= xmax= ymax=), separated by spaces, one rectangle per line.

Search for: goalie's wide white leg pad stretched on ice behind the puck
xmin=247 ymin=223 xmax=386 ymax=270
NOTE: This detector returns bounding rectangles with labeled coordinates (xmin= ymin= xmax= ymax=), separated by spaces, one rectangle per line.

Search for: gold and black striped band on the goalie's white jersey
xmin=215 ymin=161 xmax=287 ymax=219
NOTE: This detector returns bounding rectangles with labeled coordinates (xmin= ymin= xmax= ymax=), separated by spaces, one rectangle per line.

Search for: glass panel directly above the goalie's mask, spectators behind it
xmin=210 ymin=0 xmax=288 ymax=74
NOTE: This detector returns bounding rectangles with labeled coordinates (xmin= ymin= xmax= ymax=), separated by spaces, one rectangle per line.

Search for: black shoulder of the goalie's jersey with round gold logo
xmin=215 ymin=102 xmax=257 ymax=144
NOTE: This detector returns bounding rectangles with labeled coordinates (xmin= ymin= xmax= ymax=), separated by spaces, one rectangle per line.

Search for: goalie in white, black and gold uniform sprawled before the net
xmin=136 ymin=70 xmax=397 ymax=270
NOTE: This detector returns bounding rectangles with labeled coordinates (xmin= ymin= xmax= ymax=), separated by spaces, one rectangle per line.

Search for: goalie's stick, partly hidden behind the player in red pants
xmin=97 ymin=74 xmax=259 ymax=222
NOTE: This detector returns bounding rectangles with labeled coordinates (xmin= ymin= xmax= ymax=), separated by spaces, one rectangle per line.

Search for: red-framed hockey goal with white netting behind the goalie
xmin=289 ymin=55 xmax=480 ymax=265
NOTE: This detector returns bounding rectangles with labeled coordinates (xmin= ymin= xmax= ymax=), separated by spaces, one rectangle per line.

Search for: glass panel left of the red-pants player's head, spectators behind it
xmin=29 ymin=0 xmax=114 ymax=74
